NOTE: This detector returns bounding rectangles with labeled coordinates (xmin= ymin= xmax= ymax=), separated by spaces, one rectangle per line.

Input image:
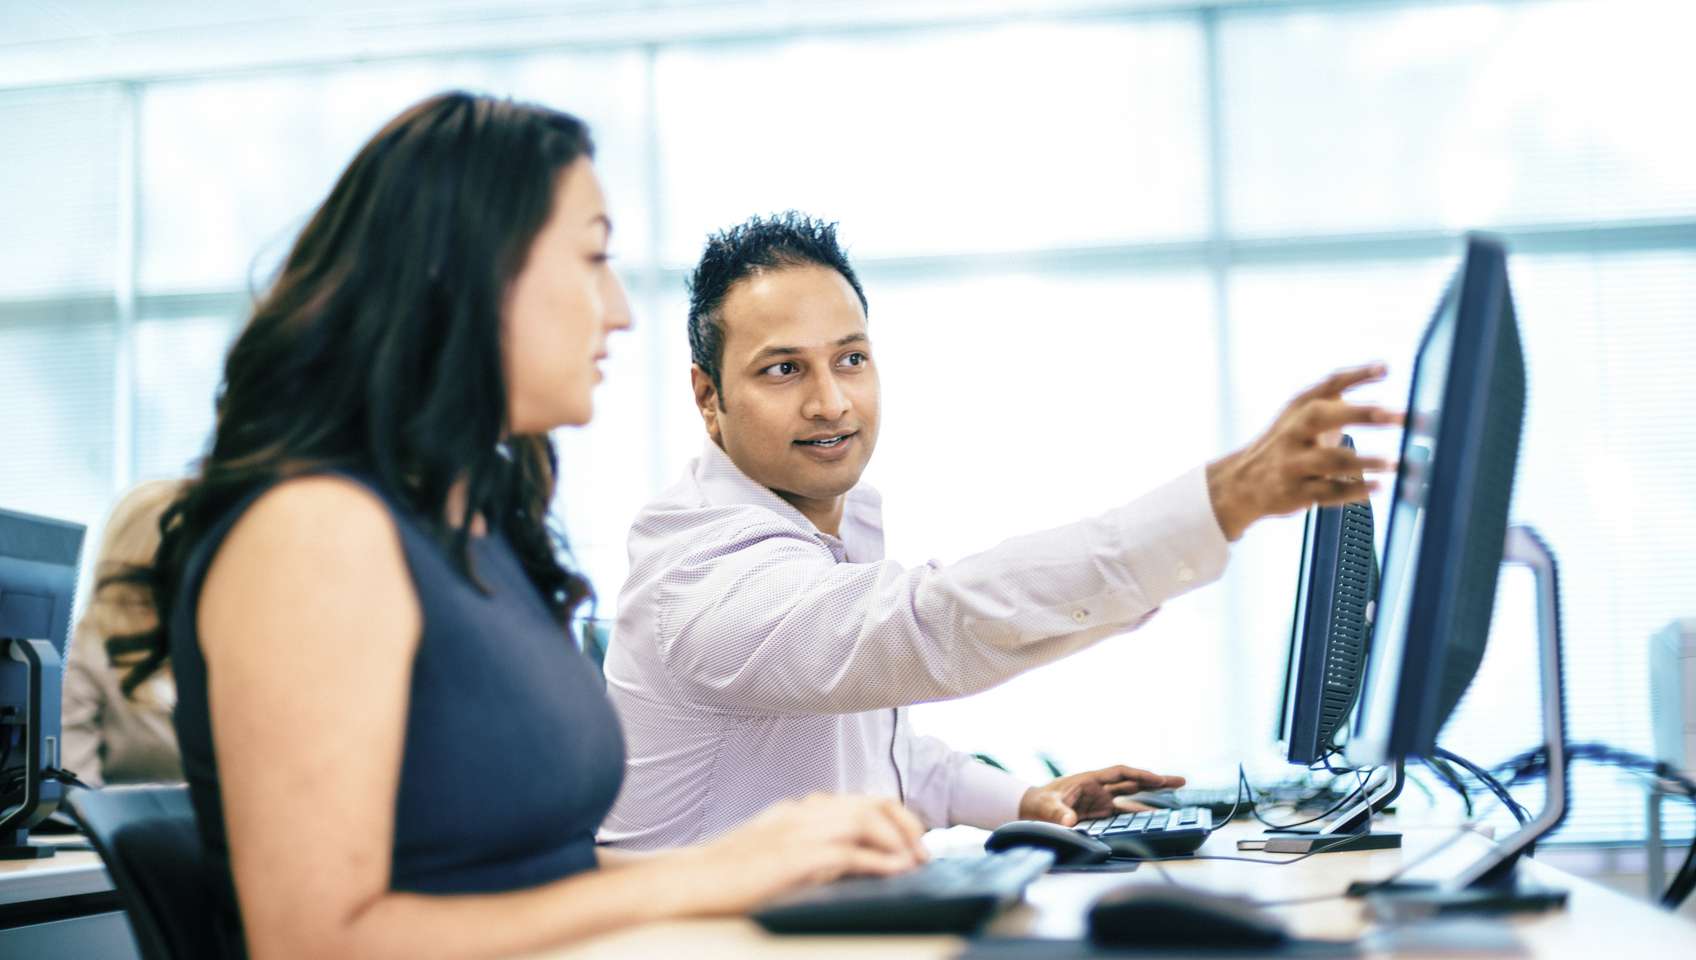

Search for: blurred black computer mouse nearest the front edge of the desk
xmin=1089 ymin=884 xmax=1289 ymax=946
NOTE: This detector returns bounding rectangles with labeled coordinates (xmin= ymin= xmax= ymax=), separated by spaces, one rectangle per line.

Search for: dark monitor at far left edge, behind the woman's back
xmin=0 ymin=511 xmax=85 ymax=860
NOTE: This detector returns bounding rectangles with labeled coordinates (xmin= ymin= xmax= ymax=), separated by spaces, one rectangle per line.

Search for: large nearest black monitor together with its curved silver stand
xmin=1347 ymin=236 xmax=1567 ymax=918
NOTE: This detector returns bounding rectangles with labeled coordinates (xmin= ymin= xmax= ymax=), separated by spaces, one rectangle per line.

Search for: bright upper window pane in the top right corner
xmin=1219 ymin=2 xmax=1696 ymax=236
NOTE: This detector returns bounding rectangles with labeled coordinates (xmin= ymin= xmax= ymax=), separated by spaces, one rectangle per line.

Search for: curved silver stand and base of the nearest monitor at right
xmin=1353 ymin=526 xmax=1569 ymax=921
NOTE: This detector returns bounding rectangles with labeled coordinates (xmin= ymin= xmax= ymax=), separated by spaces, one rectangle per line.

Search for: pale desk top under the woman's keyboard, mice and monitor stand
xmin=538 ymin=823 xmax=1696 ymax=960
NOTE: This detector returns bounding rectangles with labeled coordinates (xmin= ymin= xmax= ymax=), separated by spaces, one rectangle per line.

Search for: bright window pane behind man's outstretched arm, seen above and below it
xmin=865 ymin=270 xmax=1233 ymax=783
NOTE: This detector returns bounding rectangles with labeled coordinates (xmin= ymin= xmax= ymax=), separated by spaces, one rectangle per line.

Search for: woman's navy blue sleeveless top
xmin=170 ymin=477 xmax=624 ymax=953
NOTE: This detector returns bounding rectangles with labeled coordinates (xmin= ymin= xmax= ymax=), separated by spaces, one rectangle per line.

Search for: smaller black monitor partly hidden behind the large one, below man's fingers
xmin=1277 ymin=468 xmax=1377 ymax=765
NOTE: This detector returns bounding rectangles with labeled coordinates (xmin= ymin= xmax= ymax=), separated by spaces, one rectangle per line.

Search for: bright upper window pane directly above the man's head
xmin=656 ymin=20 xmax=1206 ymax=263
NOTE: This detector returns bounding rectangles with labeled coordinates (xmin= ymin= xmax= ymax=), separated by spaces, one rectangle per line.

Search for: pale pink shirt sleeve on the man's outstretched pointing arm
xmin=655 ymin=468 xmax=1228 ymax=722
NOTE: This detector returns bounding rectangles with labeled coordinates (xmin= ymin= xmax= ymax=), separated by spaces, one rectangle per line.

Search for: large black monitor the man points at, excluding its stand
xmin=1347 ymin=236 xmax=1525 ymax=763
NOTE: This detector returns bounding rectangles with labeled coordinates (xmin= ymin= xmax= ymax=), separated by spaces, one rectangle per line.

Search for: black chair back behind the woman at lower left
xmin=68 ymin=785 xmax=222 ymax=960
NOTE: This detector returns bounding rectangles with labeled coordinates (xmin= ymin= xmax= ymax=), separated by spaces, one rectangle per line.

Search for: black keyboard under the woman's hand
xmin=753 ymin=846 xmax=1055 ymax=933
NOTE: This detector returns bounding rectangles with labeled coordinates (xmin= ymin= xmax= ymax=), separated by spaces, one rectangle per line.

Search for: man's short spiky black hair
xmin=689 ymin=210 xmax=867 ymax=404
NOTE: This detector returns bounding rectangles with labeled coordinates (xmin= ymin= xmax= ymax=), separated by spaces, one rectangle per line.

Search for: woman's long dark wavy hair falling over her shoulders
xmin=107 ymin=92 xmax=594 ymax=692
